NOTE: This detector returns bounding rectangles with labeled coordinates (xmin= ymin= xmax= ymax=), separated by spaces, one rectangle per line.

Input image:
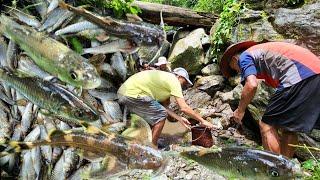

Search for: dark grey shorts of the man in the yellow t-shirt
xmin=118 ymin=95 xmax=168 ymax=126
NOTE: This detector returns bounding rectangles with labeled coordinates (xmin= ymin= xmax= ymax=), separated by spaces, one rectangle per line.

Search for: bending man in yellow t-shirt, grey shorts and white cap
xmin=118 ymin=68 xmax=215 ymax=145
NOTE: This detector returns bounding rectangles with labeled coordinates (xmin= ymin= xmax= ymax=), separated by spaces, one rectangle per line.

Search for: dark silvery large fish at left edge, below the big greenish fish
xmin=0 ymin=69 xmax=99 ymax=124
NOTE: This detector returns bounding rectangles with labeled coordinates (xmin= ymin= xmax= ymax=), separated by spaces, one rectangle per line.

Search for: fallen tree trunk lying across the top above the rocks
xmin=132 ymin=1 xmax=218 ymax=27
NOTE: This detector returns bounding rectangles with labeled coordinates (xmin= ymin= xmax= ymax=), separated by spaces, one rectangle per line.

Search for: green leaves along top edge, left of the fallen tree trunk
xmin=77 ymin=0 xmax=141 ymax=18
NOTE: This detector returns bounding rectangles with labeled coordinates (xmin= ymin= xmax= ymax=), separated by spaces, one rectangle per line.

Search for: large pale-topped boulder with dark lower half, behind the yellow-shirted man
xmin=168 ymin=28 xmax=207 ymax=75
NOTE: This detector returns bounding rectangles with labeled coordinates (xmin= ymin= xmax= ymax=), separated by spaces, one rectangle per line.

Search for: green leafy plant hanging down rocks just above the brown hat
xmin=211 ymin=0 xmax=243 ymax=58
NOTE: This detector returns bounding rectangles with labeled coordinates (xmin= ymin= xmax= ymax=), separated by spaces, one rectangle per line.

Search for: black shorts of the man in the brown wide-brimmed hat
xmin=262 ymin=75 xmax=320 ymax=132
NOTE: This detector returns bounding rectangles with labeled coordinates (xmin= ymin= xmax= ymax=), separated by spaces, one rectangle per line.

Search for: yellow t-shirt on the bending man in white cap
xmin=118 ymin=70 xmax=183 ymax=102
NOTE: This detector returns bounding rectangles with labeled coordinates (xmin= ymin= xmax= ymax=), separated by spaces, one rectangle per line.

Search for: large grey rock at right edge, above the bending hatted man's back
xmin=273 ymin=2 xmax=320 ymax=57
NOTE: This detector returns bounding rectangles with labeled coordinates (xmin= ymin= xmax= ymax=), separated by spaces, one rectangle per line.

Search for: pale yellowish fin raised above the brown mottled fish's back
xmin=122 ymin=114 xmax=152 ymax=145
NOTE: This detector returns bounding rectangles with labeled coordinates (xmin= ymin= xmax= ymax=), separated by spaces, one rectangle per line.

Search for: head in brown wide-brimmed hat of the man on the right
xmin=220 ymin=41 xmax=258 ymax=78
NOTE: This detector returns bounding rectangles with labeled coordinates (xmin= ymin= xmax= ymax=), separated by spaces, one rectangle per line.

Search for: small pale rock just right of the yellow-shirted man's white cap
xmin=195 ymin=75 xmax=224 ymax=96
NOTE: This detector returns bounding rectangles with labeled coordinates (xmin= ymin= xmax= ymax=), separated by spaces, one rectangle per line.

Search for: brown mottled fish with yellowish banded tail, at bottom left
xmin=9 ymin=130 xmax=164 ymax=176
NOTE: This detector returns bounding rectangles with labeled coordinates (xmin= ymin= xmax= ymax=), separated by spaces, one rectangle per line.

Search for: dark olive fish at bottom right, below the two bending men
xmin=180 ymin=147 xmax=300 ymax=179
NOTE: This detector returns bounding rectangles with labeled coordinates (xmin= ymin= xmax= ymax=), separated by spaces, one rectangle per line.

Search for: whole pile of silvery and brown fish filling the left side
xmin=0 ymin=0 xmax=164 ymax=179
